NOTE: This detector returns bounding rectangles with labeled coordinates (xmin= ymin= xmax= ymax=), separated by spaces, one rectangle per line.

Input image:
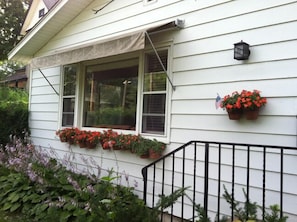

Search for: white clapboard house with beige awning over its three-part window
xmin=9 ymin=0 xmax=297 ymax=221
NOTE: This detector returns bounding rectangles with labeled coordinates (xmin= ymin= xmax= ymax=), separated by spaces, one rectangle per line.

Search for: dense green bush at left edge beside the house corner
xmin=0 ymin=88 xmax=29 ymax=145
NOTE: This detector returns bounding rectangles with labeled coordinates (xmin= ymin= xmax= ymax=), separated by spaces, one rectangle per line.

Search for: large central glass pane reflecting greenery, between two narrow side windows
xmin=84 ymin=63 xmax=138 ymax=130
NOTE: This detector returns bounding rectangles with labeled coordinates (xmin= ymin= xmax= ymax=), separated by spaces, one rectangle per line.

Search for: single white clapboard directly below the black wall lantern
xmin=173 ymin=58 xmax=296 ymax=86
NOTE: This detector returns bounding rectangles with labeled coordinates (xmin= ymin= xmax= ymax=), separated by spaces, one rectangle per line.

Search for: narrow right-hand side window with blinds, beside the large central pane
xmin=142 ymin=51 xmax=167 ymax=134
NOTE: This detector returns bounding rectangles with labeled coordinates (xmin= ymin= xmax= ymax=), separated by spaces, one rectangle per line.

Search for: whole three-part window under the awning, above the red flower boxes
xmin=62 ymin=50 xmax=168 ymax=135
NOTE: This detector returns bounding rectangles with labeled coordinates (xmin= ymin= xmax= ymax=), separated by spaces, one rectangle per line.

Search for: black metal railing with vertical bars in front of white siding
xmin=142 ymin=141 xmax=297 ymax=221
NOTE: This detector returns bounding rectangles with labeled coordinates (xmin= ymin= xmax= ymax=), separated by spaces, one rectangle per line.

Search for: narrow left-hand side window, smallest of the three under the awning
xmin=62 ymin=65 xmax=77 ymax=126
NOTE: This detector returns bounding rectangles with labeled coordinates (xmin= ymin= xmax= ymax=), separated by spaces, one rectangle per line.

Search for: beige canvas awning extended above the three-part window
xmin=31 ymin=21 xmax=180 ymax=68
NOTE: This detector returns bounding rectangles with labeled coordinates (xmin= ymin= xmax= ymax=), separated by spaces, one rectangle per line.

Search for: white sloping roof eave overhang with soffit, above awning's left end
xmin=8 ymin=0 xmax=92 ymax=63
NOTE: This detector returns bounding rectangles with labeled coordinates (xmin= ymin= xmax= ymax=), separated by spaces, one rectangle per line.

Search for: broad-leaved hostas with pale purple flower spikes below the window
xmin=0 ymin=143 xmax=158 ymax=222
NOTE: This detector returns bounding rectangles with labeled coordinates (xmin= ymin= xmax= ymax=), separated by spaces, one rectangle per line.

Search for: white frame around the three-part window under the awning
xmin=59 ymin=42 xmax=172 ymax=142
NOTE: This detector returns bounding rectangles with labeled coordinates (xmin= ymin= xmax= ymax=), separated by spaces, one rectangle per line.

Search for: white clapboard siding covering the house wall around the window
xmin=25 ymin=0 xmax=297 ymax=222
